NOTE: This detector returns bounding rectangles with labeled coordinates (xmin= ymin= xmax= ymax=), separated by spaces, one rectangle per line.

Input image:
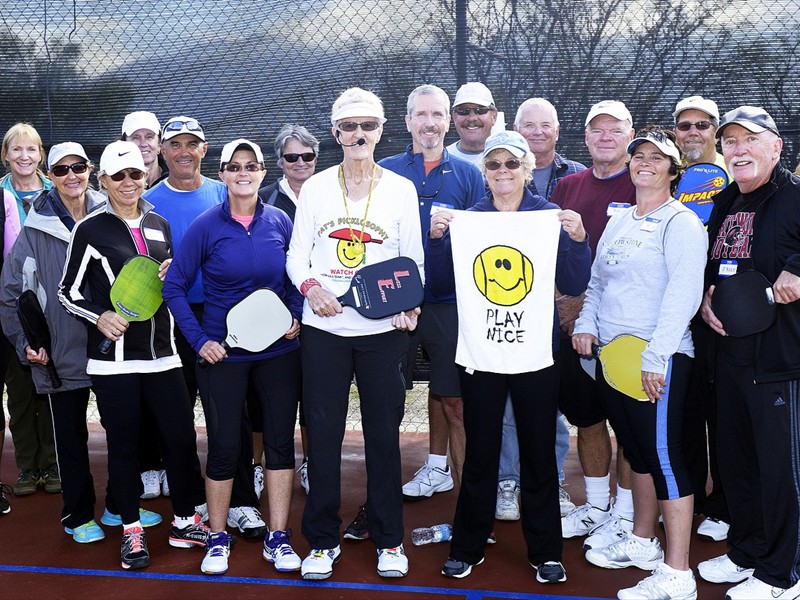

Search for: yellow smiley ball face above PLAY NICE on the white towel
xmin=472 ymin=246 xmax=533 ymax=306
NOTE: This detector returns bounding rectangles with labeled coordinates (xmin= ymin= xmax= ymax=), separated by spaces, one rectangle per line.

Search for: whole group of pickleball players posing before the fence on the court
xmin=0 ymin=82 xmax=800 ymax=600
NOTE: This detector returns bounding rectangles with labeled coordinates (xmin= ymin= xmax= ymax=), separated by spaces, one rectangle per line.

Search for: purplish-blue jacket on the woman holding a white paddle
xmin=163 ymin=199 xmax=303 ymax=361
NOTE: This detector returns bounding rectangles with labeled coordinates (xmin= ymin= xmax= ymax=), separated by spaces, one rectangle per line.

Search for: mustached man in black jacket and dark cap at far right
xmin=698 ymin=106 xmax=800 ymax=600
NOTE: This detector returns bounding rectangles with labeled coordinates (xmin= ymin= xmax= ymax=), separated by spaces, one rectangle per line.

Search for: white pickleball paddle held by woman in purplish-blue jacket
xmin=197 ymin=288 xmax=292 ymax=367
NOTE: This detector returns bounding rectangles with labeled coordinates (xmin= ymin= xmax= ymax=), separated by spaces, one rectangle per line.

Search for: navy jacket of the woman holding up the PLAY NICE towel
xmin=425 ymin=188 xmax=592 ymax=352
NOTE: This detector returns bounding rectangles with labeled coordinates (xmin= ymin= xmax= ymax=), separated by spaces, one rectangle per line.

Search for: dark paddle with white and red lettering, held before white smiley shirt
xmin=337 ymin=256 xmax=425 ymax=319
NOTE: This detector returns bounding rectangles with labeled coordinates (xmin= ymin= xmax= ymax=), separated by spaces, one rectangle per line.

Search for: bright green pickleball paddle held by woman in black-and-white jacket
xmin=100 ymin=254 xmax=164 ymax=354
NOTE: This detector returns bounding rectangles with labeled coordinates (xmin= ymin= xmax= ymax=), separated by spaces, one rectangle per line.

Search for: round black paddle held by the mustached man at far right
xmin=711 ymin=270 xmax=778 ymax=337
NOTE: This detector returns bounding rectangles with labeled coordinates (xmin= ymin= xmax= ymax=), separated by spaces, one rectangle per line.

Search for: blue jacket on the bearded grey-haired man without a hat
xmin=378 ymin=144 xmax=486 ymax=304
